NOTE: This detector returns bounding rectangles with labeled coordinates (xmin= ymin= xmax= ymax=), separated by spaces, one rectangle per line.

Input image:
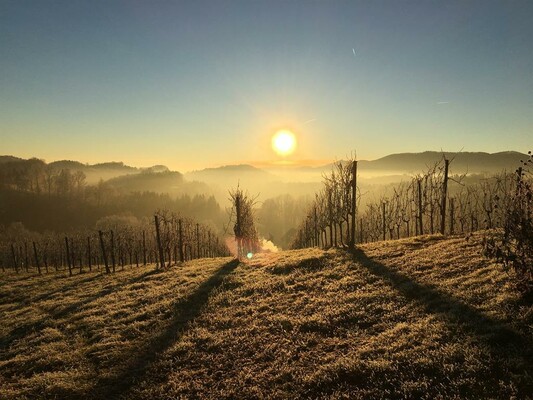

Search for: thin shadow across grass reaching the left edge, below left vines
xmin=0 ymin=269 xmax=160 ymax=354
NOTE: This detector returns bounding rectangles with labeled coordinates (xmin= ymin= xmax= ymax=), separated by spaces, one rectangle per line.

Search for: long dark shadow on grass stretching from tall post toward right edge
xmin=353 ymin=250 xmax=533 ymax=373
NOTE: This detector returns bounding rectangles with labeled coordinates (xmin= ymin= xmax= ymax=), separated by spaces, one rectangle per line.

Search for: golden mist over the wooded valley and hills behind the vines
xmin=0 ymin=152 xmax=525 ymax=249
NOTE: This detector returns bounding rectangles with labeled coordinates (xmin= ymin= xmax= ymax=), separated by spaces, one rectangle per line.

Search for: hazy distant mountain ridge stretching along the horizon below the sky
xmin=0 ymin=151 xmax=527 ymax=191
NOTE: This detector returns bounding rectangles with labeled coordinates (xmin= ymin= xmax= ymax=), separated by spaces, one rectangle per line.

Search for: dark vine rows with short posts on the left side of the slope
xmin=0 ymin=211 xmax=230 ymax=276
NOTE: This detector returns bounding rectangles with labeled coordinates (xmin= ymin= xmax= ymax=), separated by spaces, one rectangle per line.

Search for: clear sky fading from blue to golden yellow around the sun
xmin=0 ymin=0 xmax=533 ymax=171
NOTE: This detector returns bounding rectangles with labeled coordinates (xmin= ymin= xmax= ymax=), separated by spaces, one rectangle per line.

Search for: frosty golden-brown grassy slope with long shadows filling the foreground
xmin=0 ymin=236 xmax=533 ymax=399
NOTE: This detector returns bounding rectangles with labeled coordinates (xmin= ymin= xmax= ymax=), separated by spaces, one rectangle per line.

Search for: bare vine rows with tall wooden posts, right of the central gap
xmin=293 ymin=156 xmax=531 ymax=248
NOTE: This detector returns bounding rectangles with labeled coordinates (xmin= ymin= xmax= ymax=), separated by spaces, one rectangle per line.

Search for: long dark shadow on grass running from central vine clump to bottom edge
xmin=95 ymin=260 xmax=239 ymax=399
